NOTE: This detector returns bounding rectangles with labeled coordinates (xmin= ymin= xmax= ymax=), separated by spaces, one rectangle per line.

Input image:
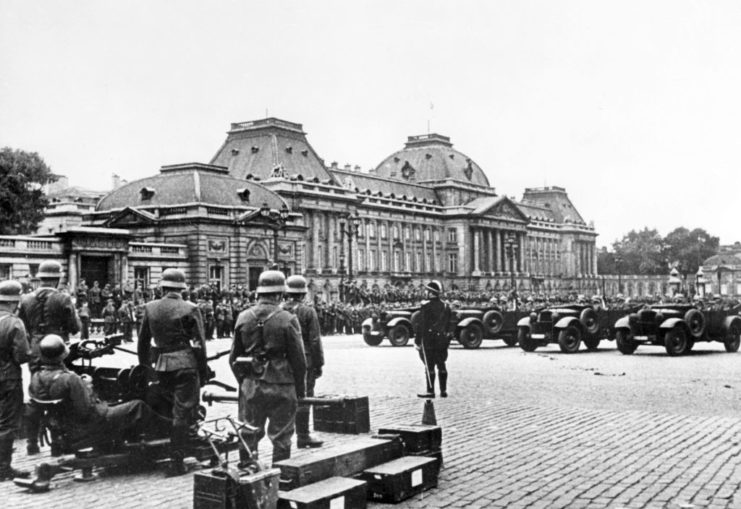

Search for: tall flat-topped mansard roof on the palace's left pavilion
xmin=211 ymin=117 xmax=332 ymax=181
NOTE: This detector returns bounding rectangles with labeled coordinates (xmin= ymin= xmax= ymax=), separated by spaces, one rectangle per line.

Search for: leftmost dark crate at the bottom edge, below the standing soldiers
xmin=193 ymin=468 xmax=280 ymax=509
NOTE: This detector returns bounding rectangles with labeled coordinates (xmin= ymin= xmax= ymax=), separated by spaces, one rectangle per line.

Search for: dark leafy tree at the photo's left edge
xmin=0 ymin=147 xmax=56 ymax=235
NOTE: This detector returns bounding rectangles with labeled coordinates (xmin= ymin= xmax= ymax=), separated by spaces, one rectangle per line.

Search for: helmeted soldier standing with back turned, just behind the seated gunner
xmin=18 ymin=260 xmax=81 ymax=454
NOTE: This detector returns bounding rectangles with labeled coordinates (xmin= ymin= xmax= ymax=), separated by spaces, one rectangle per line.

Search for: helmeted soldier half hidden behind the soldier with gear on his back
xmin=283 ymin=275 xmax=324 ymax=449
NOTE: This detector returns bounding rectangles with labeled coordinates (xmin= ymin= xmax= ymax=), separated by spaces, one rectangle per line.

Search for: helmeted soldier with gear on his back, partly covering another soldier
xmin=229 ymin=270 xmax=306 ymax=463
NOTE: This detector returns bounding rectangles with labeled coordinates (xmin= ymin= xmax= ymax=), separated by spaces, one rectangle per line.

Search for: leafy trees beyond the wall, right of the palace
xmin=597 ymin=227 xmax=719 ymax=275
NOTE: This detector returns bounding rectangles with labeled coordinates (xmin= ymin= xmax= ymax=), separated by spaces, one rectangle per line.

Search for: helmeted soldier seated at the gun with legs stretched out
xmin=29 ymin=334 xmax=171 ymax=454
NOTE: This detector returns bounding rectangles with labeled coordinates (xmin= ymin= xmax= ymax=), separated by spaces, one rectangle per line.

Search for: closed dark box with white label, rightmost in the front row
xmin=358 ymin=456 xmax=439 ymax=504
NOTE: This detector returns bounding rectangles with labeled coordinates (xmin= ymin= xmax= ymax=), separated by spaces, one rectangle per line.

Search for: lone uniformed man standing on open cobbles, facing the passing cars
xmin=414 ymin=281 xmax=451 ymax=398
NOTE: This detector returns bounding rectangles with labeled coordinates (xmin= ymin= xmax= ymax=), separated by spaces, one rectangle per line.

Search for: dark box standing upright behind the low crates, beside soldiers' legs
xmin=314 ymin=396 xmax=370 ymax=434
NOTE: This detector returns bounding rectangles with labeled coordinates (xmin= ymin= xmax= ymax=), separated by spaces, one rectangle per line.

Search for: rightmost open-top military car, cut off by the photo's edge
xmin=615 ymin=304 xmax=741 ymax=356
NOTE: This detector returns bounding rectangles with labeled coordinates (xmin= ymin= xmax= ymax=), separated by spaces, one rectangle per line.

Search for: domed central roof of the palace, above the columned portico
xmin=375 ymin=133 xmax=490 ymax=187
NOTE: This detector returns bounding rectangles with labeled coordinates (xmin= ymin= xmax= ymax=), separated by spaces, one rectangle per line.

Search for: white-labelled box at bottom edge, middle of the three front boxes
xmin=278 ymin=477 xmax=368 ymax=509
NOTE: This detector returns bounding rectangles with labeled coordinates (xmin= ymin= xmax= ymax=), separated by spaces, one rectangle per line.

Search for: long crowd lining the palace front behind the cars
xmin=47 ymin=279 xmax=739 ymax=341
